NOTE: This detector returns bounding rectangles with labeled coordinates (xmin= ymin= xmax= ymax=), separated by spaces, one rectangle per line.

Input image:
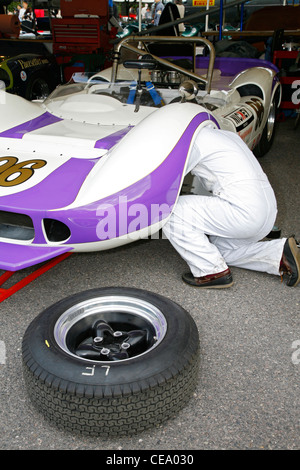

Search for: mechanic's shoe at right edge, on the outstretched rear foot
xmin=279 ymin=237 xmax=300 ymax=287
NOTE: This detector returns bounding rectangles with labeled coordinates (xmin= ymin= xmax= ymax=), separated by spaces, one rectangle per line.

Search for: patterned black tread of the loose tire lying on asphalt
xmin=23 ymin=353 xmax=198 ymax=437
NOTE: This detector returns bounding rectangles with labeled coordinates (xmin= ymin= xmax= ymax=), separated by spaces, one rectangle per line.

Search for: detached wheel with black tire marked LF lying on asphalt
xmin=22 ymin=287 xmax=199 ymax=437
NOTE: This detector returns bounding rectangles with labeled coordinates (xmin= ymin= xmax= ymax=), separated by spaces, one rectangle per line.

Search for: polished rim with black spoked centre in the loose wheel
xmin=54 ymin=296 xmax=167 ymax=363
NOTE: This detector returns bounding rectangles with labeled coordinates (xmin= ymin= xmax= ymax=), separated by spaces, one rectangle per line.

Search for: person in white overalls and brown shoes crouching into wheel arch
xmin=163 ymin=127 xmax=300 ymax=288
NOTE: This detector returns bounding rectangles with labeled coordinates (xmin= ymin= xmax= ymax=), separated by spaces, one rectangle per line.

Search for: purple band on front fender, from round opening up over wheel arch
xmin=58 ymin=112 xmax=219 ymax=245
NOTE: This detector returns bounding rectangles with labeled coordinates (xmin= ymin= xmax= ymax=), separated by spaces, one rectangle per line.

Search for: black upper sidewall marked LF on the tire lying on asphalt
xmin=23 ymin=288 xmax=199 ymax=396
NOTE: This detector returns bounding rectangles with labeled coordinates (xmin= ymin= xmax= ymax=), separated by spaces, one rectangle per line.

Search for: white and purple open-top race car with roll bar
xmin=0 ymin=36 xmax=281 ymax=271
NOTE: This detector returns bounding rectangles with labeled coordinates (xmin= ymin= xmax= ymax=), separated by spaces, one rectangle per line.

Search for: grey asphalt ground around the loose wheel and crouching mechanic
xmin=0 ymin=115 xmax=300 ymax=451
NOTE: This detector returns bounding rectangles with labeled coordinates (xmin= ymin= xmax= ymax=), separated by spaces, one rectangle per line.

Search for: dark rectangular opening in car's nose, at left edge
xmin=0 ymin=211 xmax=34 ymax=241
